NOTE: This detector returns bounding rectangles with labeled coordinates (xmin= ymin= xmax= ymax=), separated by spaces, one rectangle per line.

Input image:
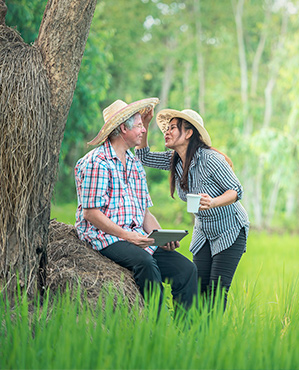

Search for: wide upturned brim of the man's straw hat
xmin=88 ymin=98 xmax=159 ymax=145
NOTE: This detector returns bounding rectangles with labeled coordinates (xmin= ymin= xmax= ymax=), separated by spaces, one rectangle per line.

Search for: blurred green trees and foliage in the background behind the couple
xmin=6 ymin=0 xmax=299 ymax=227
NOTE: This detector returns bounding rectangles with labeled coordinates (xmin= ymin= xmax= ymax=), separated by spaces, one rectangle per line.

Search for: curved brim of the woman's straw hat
xmin=156 ymin=109 xmax=212 ymax=146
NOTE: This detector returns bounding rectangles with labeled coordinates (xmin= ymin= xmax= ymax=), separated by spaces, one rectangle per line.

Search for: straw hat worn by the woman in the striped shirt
xmin=156 ymin=109 xmax=212 ymax=146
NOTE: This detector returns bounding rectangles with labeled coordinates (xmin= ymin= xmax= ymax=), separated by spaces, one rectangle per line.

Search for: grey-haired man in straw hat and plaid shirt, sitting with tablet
xmin=75 ymin=98 xmax=197 ymax=308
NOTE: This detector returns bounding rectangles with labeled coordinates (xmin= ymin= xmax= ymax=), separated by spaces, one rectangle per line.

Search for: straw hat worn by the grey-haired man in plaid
xmin=88 ymin=98 xmax=159 ymax=145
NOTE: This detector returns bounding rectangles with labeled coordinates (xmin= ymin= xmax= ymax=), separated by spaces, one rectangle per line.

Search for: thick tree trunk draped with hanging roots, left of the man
xmin=0 ymin=0 xmax=96 ymax=296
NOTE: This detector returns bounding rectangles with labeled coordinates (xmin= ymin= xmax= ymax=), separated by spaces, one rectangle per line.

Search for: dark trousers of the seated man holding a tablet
xmin=100 ymin=241 xmax=197 ymax=308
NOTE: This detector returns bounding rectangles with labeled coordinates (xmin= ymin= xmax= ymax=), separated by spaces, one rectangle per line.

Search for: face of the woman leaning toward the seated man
xmin=164 ymin=118 xmax=190 ymax=151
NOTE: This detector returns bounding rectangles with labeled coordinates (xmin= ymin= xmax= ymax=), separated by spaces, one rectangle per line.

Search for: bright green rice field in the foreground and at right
xmin=0 ymin=207 xmax=299 ymax=370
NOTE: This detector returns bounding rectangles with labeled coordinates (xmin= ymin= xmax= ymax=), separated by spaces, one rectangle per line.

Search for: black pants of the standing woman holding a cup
xmin=193 ymin=228 xmax=246 ymax=309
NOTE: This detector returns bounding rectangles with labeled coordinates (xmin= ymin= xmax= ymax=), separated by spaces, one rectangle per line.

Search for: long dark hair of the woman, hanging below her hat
xmin=169 ymin=118 xmax=233 ymax=198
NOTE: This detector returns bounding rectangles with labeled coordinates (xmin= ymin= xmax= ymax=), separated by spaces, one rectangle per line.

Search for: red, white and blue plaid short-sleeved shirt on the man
xmin=75 ymin=140 xmax=157 ymax=254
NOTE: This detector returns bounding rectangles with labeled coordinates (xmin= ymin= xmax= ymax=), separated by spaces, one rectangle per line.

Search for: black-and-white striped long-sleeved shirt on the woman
xmin=135 ymin=147 xmax=249 ymax=256
